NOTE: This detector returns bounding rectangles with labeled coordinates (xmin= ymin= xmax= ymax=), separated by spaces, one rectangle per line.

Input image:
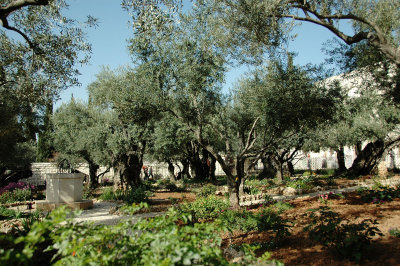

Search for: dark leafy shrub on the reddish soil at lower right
xmin=304 ymin=206 xmax=383 ymax=262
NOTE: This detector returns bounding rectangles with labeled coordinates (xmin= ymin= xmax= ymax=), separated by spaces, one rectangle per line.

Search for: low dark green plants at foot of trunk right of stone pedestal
xmin=99 ymin=186 xmax=151 ymax=203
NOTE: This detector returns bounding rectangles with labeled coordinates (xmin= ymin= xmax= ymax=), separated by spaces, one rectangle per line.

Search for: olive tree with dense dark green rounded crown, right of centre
xmin=238 ymin=54 xmax=338 ymax=181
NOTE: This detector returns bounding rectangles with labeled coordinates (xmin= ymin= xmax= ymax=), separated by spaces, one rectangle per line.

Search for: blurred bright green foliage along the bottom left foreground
xmin=0 ymin=206 xmax=238 ymax=265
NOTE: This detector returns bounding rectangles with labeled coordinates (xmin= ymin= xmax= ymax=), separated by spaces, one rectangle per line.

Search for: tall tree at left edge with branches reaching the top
xmin=0 ymin=0 xmax=94 ymax=181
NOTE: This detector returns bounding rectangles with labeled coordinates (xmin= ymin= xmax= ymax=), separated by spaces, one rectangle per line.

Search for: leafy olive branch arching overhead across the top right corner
xmin=220 ymin=0 xmax=400 ymax=66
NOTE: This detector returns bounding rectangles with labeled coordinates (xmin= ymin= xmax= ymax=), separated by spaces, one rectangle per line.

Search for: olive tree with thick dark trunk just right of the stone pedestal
xmin=88 ymin=65 xmax=162 ymax=188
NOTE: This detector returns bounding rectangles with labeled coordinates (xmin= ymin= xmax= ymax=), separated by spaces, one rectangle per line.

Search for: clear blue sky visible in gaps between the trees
xmin=55 ymin=0 xmax=346 ymax=108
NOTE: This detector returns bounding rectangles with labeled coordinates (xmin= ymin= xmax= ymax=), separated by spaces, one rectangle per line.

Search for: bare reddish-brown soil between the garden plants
xmin=151 ymin=188 xmax=400 ymax=265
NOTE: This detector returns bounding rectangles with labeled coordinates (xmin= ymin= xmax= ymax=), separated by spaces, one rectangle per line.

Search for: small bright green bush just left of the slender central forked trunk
xmin=179 ymin=196 xmax=229 ymax=221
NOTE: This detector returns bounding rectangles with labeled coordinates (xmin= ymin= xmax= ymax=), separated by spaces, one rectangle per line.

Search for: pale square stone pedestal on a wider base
xmin=36 ymin=173 xmax=93 ymax=210
